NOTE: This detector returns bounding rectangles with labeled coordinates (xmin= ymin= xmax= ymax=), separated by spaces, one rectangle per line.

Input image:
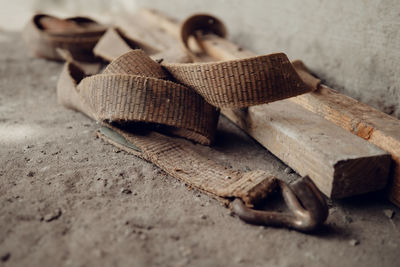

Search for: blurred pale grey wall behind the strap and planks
xmin=0 ymin=0 xmax=400 ymax=118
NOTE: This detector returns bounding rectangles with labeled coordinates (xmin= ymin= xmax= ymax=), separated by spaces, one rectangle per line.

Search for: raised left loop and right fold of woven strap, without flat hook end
xmin=59 ymin=45 xmax=311 ymax=144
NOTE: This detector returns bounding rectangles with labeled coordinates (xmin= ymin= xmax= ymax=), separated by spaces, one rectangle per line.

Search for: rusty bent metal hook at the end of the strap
xmin=231 ymin=176 xmax=328 ymax=232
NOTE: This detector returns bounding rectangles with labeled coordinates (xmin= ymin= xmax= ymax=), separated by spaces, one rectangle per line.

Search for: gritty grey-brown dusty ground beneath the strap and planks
xmin=0 ymin=32 xmax=400 ymax=267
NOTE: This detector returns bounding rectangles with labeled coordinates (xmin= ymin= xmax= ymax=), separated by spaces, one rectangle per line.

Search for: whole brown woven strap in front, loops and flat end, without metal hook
xmin=39 ymin=12 xmax=315 ymax=206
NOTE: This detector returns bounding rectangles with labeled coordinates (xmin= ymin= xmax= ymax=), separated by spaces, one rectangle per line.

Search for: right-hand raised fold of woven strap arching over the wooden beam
xmin=163 ymin=53 xmax=313 ymax=108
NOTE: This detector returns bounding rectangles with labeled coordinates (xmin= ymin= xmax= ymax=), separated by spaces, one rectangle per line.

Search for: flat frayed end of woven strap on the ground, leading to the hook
xmin=98 ymin=124 xmax=277 ymax=207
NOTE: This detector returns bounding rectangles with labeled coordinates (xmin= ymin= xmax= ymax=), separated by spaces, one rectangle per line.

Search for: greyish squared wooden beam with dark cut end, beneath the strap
xmin=119 ymin=11 xmax=390 ymax=198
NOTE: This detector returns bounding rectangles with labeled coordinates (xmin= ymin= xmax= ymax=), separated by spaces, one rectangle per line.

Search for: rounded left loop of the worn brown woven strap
xmin=58 ymin=50 xmax=219 ymax=147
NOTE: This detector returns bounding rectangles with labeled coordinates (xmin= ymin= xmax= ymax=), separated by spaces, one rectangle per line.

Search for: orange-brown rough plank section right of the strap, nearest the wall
xmin=291 ymin=86 xmax=400 ymax=206
